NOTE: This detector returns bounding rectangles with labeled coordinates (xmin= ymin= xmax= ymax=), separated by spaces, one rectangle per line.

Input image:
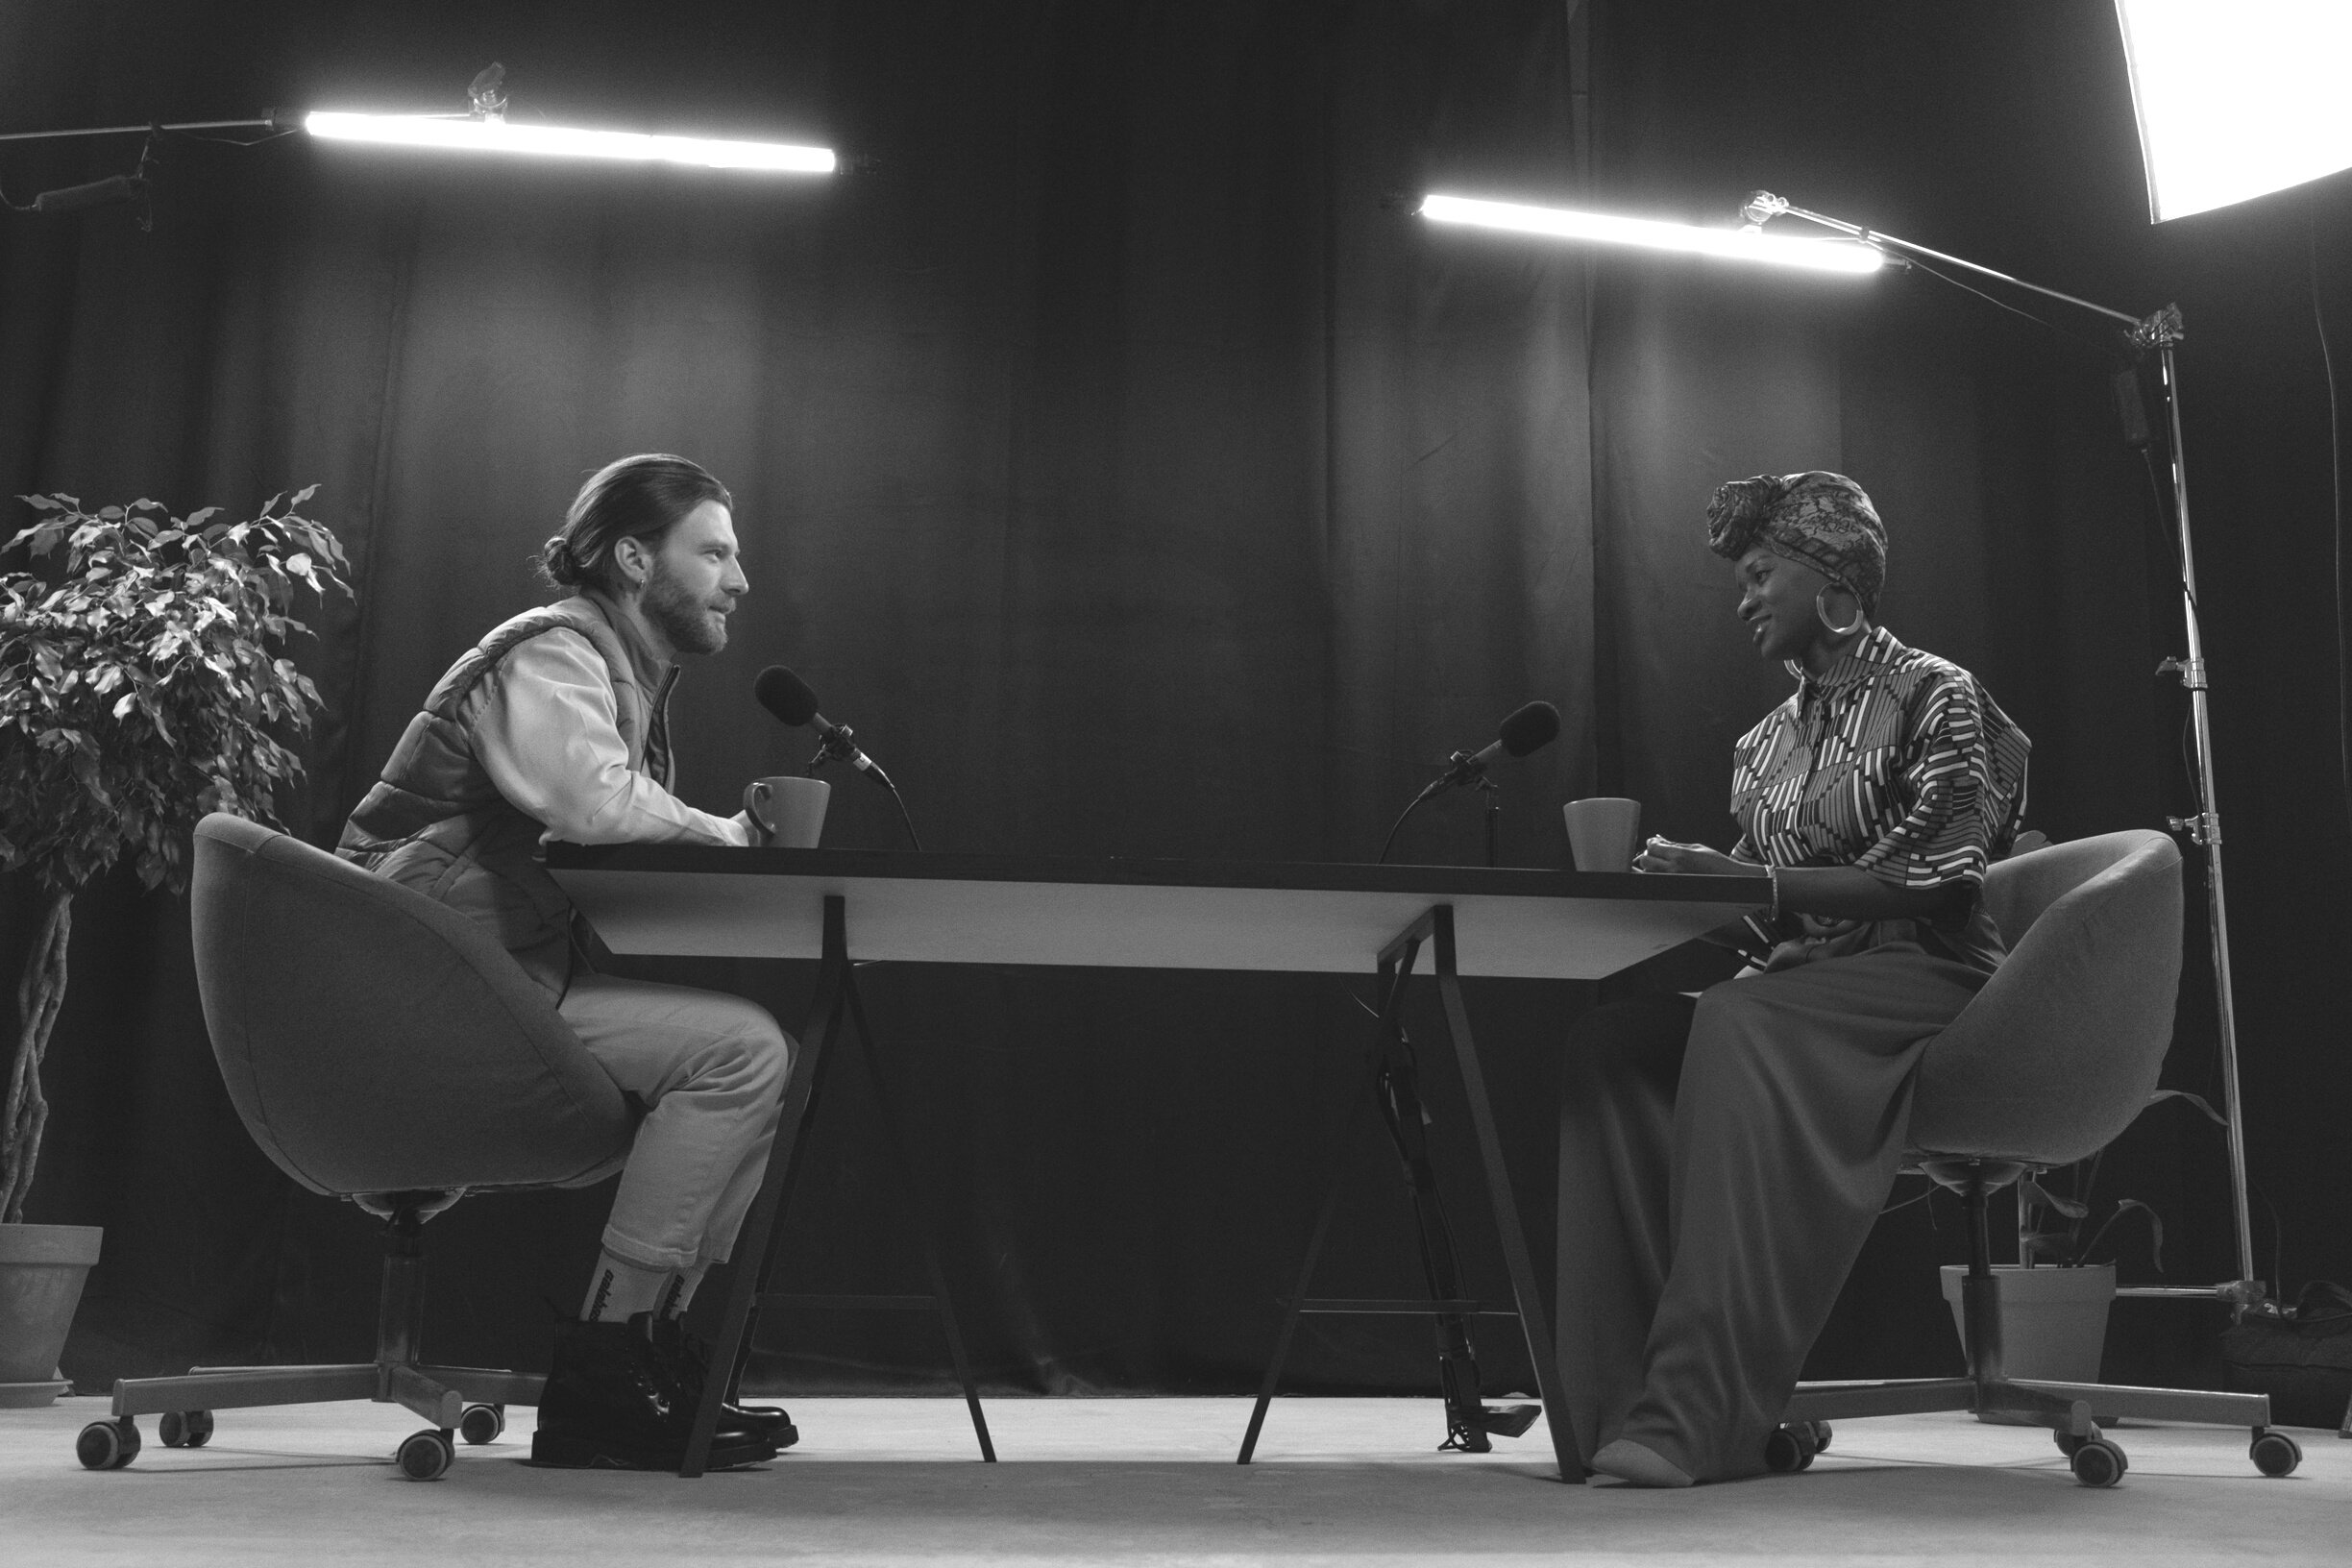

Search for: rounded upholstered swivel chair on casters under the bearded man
xmin=75 ymin=814 xmax=635 ymax=1481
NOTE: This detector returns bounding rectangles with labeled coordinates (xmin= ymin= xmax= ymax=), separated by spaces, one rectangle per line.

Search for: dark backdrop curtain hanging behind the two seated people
xmin=0 ymin=0 xmax=2352 ymax=1391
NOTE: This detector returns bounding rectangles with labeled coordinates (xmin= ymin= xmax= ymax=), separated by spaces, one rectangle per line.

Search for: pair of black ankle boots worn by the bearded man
xmin=531 ymin=1311 xmax=776 ymax=1469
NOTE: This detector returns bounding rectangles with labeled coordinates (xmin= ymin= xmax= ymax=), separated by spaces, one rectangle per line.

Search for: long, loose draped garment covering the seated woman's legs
xmin=1559 ymin=943 xmax=1985 ymax=1481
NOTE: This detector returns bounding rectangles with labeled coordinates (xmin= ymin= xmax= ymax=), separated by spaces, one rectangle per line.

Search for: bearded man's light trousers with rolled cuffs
xmin=557 ymin=975 xmax=793 ymax=1269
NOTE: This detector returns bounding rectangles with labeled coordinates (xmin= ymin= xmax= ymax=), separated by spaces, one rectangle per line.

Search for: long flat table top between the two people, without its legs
xmin=548 ymin=844 xmax=1764 ymax=980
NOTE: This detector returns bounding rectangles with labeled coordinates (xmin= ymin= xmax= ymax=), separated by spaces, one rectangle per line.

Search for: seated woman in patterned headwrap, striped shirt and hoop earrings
xmin=1559 ymin=470 xmax=2030 ymax=1485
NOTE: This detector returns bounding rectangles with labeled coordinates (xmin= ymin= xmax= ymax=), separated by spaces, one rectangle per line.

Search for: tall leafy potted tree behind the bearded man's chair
xmin=0 ymin=486 xmax=348 ymax=1404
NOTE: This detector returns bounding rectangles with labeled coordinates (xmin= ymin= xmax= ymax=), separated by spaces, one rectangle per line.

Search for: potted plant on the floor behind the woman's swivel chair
xmin=1943 ymin=1089 xmax=2220 ymax=1420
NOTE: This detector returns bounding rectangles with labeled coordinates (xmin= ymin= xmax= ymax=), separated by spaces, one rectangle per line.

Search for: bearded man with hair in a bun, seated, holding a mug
xmin=336 ymin=453 xmax=799 ymax=1469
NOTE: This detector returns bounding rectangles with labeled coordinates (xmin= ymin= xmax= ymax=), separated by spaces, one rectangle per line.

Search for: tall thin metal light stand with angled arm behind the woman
xmin=1741 ymin=190 xmax=2265 ymax=1310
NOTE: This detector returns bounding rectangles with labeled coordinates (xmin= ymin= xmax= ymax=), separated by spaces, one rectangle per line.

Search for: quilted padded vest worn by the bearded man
xmin=334 ymin=597 xmax=671 ymax=1001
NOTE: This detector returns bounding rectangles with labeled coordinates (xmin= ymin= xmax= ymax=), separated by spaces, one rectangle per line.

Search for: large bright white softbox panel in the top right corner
xmin=2115 ymin=0 xmax=2352 ymax=223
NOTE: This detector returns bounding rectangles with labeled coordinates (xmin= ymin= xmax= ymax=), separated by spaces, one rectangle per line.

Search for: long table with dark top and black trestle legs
xmin=548 ymin=844 xmax=1757 ymax=1479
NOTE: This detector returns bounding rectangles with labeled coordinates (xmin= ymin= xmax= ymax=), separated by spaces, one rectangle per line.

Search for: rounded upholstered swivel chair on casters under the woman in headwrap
xmin=1764 ymin=830 xmax=2303 ymax=1485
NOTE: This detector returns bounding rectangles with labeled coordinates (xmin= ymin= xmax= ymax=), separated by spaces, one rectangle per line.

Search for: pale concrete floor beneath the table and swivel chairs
xmin=0 ymin=1399 xmax=2352 ymax=1568
